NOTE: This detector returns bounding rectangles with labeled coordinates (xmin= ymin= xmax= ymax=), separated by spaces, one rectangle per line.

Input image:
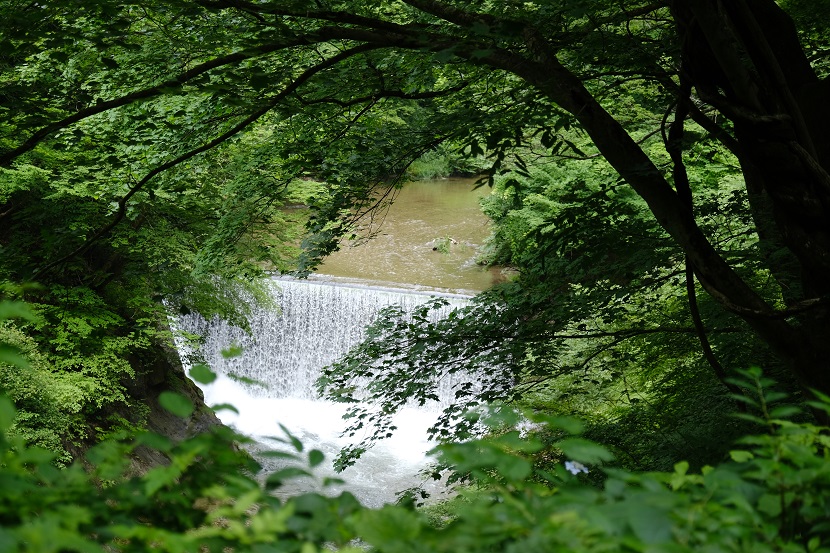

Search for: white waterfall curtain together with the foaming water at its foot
xmin=177 ymin=280 xmax=467 ymax=506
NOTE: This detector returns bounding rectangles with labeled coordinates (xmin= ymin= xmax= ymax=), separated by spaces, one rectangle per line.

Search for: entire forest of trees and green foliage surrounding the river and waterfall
xmin=0 ymin=0 xmax=830 ymax=553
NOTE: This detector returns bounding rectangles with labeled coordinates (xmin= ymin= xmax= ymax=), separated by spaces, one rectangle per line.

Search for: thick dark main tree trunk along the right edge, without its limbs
xmin=673 ymin=0 xmax=830 ymax=402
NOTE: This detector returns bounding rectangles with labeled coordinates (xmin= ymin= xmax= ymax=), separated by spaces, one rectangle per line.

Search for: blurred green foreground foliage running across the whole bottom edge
xmin=0 ymin=372 xmax=830 ymax=553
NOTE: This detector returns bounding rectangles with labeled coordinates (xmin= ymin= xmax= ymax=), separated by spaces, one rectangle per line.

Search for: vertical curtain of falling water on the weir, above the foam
xmin=178 ymin=279 xmax=467 ymax=399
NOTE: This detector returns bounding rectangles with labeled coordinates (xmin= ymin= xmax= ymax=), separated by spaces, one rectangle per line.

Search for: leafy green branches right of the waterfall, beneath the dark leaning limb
xmin=320 ymin=152 xmax=792 ymax=470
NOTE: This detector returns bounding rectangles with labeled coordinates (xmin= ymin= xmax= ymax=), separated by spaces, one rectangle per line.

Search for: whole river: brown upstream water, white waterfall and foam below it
xmin=178 ymin=179 xmax=498 ymax=506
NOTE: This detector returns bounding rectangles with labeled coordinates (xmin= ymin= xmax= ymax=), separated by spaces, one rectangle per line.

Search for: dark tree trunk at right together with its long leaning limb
xmin=490 ymin=0 xmax=830 ymax=402
